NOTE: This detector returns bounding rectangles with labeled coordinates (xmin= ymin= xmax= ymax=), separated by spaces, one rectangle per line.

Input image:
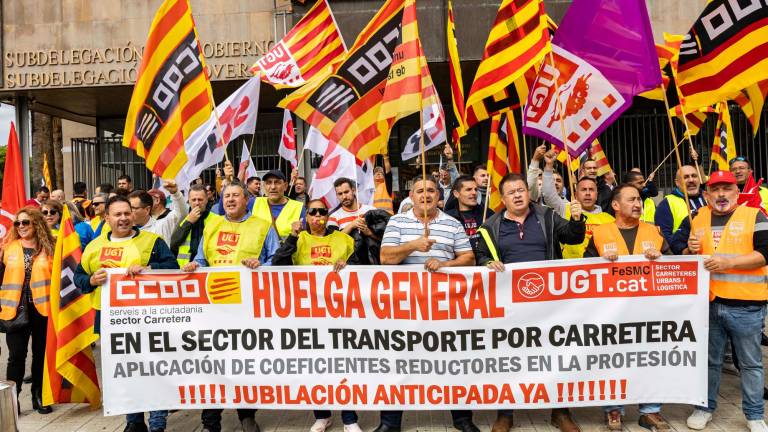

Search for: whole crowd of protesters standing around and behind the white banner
xmin=0 ymin=146 xmax=768 ymax=432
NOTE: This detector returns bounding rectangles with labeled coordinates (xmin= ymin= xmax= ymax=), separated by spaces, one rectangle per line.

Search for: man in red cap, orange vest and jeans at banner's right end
xmin=687 ymin=171 xmax=768 ymax=432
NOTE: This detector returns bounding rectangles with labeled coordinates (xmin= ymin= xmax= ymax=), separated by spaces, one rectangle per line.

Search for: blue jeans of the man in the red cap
xmin=697 ymin=303 xmax=766 ymax=420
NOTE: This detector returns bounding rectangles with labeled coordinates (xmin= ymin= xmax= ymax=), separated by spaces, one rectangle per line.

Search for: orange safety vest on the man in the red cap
xmin=691 ymin=206 xmax=768 ymax=301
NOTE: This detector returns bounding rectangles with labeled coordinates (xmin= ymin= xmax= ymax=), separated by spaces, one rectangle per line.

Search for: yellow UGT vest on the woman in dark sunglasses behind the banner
xmin=291 ymin=231 xmax=355 ymax=265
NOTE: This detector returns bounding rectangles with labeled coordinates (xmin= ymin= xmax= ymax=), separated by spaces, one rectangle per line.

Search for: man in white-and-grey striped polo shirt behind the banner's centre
xmin=374 ymin=176 xmax=479 ymax=432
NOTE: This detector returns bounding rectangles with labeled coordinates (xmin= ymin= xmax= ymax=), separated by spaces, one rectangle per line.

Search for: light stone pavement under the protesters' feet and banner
xmin=0 ymin=335 xmax=768 ymax=432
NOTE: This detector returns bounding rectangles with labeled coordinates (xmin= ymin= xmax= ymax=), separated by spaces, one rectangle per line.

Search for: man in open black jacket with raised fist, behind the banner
xmin=477 ymin=173 xmax=586 ymax=432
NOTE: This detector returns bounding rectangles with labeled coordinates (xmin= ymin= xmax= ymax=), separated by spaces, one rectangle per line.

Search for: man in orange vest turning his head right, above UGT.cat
xmin=584 ymin=183 xmax=672 ymax=431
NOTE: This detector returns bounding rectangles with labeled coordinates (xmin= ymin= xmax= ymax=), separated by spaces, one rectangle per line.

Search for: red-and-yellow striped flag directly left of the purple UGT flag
xmin=465 ymin=0 xmax=551 ymax=128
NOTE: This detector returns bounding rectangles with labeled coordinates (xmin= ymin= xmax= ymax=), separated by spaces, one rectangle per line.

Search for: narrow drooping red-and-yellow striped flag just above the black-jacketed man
xmin=488 ymin=111 xmax=521 ymax=212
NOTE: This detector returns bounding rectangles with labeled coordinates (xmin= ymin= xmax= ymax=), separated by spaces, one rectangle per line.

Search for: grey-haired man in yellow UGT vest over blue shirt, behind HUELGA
xmin=181 ymin=181 xmax=280 ymax=432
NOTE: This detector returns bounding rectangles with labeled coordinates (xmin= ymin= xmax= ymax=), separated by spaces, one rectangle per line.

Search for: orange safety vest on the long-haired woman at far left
xmin=0 ymin=240 xmax=53 ymax=320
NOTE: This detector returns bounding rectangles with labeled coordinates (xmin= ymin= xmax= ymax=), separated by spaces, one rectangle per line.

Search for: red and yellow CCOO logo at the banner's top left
xmin=109 ymin=271 xmax=242 ymax=307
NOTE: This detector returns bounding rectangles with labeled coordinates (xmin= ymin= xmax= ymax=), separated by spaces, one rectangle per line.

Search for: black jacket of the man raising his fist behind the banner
xmin=475 ymin=203 xmax=587 ymax=265
